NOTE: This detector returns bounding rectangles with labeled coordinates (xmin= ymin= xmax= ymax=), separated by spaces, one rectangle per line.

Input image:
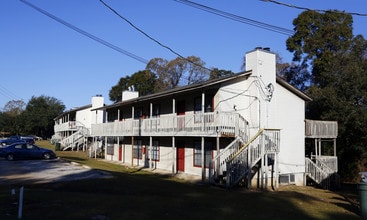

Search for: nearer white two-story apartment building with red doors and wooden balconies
xmin=55 ymin=48 xmax=337 ymax=187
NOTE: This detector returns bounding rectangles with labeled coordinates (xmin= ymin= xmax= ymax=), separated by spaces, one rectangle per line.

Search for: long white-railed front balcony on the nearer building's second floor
xmin=91 ymin=112 xmax=247 ymax=137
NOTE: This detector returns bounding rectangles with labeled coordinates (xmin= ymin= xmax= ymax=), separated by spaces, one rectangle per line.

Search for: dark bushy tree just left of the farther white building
xmin=22 ymin=96 xmax=65 ymax=138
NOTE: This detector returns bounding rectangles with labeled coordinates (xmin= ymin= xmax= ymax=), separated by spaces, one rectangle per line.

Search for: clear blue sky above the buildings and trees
xmin=0 ymin=0 xmax=367 ymax=110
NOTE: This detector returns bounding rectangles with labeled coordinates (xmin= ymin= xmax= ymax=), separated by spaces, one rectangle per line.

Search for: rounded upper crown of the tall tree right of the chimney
xmin=287 ymin=11 xmax=353 ymax=86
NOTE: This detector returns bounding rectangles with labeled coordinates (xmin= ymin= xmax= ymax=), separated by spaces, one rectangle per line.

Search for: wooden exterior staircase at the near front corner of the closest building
xmin=209 ymin=129 xmax=280 ymax=188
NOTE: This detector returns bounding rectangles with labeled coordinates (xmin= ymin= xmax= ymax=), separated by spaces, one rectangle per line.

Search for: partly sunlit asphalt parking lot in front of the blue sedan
xmin=0 ymin=158 xmax=111 ymax=185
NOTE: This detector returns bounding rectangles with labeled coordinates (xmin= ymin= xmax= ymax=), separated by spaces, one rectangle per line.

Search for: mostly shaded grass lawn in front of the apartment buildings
xmin=0 ymin=141 xmax=360 ymax=220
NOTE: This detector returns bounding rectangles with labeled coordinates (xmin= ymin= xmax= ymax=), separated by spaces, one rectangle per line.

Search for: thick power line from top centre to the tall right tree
xmin=174 ymin=0 xmax=294 ymax=36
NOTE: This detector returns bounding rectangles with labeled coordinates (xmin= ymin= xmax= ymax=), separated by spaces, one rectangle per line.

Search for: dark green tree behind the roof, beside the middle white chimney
xmin=109 ymin=70 xmax=156 ymax=102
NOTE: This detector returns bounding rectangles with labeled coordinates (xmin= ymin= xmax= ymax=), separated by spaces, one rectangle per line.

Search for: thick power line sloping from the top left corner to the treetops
xmin=20 ymin=0 xmax=148 ymax=64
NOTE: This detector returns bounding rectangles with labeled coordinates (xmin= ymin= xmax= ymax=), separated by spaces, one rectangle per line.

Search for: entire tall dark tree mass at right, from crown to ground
xmin=287 ymin=11 xmax=367 ymax=180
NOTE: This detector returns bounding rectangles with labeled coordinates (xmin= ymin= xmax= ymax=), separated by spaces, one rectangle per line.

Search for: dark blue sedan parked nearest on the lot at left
xmin=0 ymin=142 xmax=56 ymax=160
